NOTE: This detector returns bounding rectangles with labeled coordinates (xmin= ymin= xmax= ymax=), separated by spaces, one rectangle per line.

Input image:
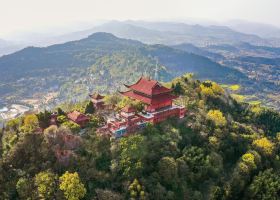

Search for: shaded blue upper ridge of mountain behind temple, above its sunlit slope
xmin=0 ymin=32 xmax=241 ymax=81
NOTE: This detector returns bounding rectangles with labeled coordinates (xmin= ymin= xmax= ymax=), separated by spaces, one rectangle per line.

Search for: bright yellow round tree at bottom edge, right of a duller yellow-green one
xmin=59 ymin=171 xmax=86 ymax=200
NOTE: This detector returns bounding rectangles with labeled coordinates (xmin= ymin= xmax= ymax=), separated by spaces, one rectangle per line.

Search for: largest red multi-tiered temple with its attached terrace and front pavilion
xmin=97 ymin=77 xmax=186 ymax=137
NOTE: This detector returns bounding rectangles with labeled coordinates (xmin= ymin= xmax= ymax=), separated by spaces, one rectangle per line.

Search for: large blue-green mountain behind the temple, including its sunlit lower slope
xmin=0 ymin=33 xmax=246 ymax=108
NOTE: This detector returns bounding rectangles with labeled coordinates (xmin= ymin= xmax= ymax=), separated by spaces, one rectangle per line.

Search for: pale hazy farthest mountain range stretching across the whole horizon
xmin=0 ymin=21 xmax=280 ymax=56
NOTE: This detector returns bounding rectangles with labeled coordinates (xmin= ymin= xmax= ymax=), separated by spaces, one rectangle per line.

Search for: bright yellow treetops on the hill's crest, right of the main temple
xmin=200 ymin=81 xmax=224 ymax=96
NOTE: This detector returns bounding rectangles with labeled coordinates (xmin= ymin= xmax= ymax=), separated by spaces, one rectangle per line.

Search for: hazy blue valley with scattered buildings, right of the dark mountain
xmin=173 ymin=43 xmax=280 ymax=110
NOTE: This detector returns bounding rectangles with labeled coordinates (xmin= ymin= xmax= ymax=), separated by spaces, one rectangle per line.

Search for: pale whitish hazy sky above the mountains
xmin=0 ymin=0 xmax=280 ymax=40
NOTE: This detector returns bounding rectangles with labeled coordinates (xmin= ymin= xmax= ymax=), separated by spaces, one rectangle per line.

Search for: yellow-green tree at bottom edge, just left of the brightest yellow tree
xmin=35 ymin=171 xmax=57 ymax=199
